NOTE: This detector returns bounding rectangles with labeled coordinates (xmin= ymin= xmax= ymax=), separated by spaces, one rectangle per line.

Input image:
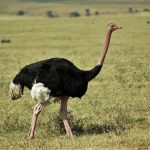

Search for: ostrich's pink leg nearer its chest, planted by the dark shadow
xmin=59 ymin=96 xmax=72 ymax=137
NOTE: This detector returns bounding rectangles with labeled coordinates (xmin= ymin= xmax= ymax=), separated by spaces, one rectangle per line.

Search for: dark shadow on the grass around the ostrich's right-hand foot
xmin=53 ymin=112 xmax=125 ymax=136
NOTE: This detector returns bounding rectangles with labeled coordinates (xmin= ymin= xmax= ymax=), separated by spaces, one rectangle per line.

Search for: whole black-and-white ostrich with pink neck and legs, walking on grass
xmin=10 ymin=23 xmax=121 ymax=139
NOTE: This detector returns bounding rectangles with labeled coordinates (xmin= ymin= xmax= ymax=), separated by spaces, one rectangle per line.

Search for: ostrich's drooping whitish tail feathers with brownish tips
xmin=9 ymin=81 xmax=23 ymax=100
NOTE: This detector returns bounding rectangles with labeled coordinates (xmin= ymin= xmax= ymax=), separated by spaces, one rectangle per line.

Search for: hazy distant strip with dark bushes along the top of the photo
xmin=0 ymin=0 xmax=150 ymax=18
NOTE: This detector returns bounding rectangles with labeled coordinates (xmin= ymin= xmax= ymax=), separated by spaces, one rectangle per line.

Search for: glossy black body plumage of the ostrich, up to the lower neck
xmin=13 ymin=58 xmax=102 ymax=98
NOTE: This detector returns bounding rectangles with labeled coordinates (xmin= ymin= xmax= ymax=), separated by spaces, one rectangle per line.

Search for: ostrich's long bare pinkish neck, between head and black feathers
xmin=98 ymin=30 xmax=112 ymax=65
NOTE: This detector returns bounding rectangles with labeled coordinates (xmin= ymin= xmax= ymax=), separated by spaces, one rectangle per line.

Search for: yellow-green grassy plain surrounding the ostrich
xmin=0 ymin=0 xmax=150 ymax=150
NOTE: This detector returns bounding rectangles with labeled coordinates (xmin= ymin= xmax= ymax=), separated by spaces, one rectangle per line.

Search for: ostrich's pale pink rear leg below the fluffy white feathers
xmin=29 ymin=103 xmax=42 ymax=139
